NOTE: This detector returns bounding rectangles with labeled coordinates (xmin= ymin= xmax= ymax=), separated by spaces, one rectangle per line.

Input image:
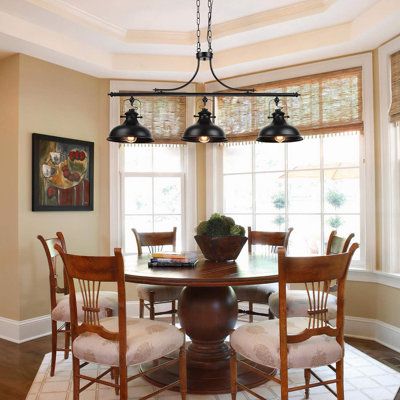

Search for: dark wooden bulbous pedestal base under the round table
xmin=141 ymin=286 xmax=275 ymax=394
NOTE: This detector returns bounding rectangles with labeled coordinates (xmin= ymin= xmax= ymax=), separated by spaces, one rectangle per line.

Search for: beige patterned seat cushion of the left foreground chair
xmin=72 ymin=317 xmax=184 ymax=366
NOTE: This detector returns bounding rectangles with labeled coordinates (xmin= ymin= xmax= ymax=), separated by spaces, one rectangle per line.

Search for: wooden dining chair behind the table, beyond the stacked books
xmin=132 ymin=227 xmax=182 ymax=325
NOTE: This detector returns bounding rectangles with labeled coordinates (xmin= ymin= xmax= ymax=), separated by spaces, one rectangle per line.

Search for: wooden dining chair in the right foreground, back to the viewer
xmin=230 ymin=243 xmax=358 ymax=400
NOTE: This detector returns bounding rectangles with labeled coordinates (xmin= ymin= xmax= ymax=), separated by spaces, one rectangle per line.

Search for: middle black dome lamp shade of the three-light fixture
xmin=182 ymin=97 xmax=227 ymax=143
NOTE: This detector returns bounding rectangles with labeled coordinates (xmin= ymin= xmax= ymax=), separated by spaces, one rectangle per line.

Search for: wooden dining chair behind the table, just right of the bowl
xmin=233 ymin=226 xmax=293 ymax=322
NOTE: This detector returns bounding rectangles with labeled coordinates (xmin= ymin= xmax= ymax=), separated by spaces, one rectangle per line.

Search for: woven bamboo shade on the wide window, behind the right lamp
xmin=216 ymin=68 xmax=363 ymax=141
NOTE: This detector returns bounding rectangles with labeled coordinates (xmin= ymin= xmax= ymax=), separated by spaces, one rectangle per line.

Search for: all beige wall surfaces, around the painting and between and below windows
xmin=0 ymin=53 xmax=400 ymax=327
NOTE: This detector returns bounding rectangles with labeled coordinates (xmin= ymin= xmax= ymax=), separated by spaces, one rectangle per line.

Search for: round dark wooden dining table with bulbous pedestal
xmin=124 ymin=251 xmax=278 ymax=394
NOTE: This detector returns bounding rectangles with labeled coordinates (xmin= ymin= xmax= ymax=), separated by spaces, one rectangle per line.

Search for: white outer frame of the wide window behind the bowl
xmin=205 ymin=52 xmax=376 ymax=272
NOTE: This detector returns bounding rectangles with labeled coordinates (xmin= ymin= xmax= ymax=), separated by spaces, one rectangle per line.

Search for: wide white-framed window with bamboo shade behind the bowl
xmin=208 ymin=64 xmax=375 ymax=268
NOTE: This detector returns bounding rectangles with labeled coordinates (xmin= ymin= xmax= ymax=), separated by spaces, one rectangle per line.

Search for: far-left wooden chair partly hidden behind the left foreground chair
xmin=37 ymin=232 xmax=118 ymax=376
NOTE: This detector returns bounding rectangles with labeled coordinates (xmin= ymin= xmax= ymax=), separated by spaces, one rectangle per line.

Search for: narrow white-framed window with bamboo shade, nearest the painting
xmin=109 ymin=81 xmax=197 ymax=254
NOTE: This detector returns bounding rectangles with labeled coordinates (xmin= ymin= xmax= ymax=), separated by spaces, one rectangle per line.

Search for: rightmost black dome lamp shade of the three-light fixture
xmin=257 ymin=97 xmax=303 ymax=143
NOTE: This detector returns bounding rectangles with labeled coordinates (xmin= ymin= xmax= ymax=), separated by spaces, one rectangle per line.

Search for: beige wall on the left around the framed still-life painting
xmin=0 ymin=55 xmax=109 ymax=320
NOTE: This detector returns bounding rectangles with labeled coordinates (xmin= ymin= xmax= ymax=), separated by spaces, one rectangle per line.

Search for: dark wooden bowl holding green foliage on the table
xmin=194 ymin=235 xmax=247 ymax=262
